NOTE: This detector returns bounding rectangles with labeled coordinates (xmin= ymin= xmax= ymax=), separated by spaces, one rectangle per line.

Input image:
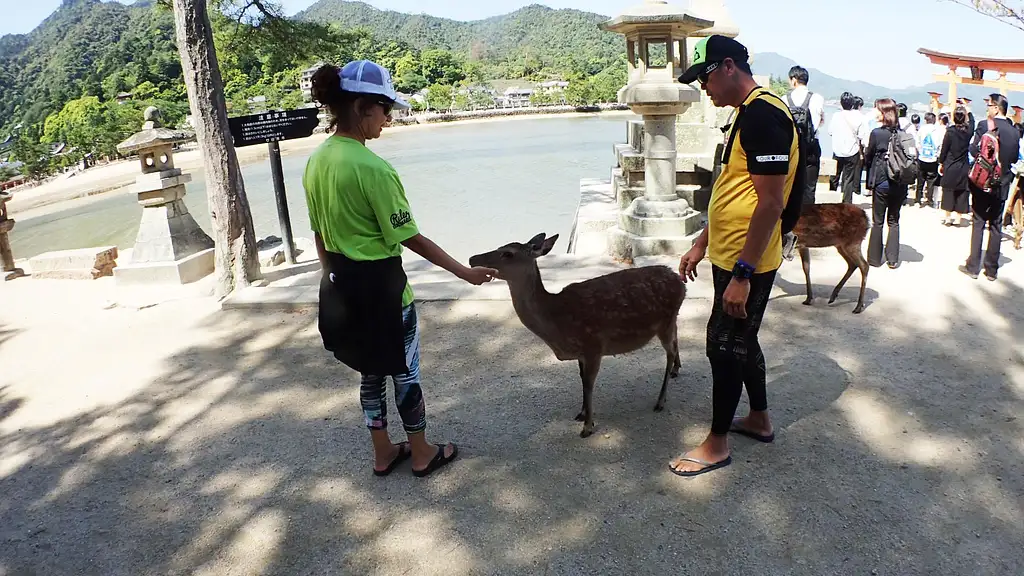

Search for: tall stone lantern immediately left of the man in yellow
xmin=601 ymin=0 xmax=715 ymax=255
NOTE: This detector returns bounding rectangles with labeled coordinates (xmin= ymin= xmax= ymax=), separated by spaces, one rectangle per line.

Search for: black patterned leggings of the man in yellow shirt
xmin=708 ymin=266 xmax=776 ymax=435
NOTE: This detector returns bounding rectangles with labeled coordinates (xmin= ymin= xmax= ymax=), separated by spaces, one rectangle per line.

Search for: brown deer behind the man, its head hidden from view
xmin=793 ymin=204 xmax=868 ymax=314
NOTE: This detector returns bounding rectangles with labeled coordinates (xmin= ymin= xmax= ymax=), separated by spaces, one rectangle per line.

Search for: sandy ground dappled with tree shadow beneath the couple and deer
xmin=0 ymin=270 xmax=1024 ymax=576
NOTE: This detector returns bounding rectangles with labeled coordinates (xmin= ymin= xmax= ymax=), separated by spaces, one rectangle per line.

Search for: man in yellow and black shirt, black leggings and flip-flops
xmin=670 ymin=36 xmax=800 ymax=476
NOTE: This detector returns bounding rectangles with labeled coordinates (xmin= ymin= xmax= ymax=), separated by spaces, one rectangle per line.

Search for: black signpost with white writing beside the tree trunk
xmin=227 ymin=108 xmax=319 ymax=264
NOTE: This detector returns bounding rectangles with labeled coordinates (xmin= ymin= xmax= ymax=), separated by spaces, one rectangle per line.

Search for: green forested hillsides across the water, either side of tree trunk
xmin=0 ymin=0 xmax=626 ymax=161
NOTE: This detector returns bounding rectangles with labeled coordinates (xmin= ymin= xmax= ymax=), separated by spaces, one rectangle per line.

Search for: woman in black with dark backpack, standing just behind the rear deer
xmin=864 ymin=98 xmax=907 ymax=269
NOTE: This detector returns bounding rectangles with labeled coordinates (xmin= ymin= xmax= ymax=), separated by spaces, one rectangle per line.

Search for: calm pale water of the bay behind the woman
xmin=11 ymin=111 xmax=834 ymax=261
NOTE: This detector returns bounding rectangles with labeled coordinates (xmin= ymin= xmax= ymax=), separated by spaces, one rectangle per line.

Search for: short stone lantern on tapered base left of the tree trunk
xmin=114 ymin=107 xmax=214 ymax=285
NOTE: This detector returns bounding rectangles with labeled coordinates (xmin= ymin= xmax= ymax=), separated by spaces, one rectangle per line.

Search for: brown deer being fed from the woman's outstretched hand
xmin=469 ymin=234 xmax=686 ymax=438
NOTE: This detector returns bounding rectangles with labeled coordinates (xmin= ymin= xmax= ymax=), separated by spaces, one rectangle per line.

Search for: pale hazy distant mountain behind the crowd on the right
xmin=751 ymin=52 xmax=1024 ymax=106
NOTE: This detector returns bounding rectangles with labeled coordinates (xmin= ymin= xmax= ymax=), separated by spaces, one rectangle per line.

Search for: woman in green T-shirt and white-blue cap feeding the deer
xmin=303 ymin=60 xmax=497 ymax=477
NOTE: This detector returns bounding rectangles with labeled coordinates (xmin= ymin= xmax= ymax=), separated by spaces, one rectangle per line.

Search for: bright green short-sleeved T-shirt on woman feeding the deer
xmin=302 ymin=136 xmax=420 ymax=306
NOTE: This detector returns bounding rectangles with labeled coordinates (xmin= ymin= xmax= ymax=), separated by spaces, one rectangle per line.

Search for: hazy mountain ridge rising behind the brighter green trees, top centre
xmin=295 ymin=0 xmax=626 ymax=65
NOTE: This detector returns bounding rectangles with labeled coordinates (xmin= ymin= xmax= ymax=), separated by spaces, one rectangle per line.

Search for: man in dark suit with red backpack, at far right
xmin=959 ymin=94 xmax=1020 ymax=281
